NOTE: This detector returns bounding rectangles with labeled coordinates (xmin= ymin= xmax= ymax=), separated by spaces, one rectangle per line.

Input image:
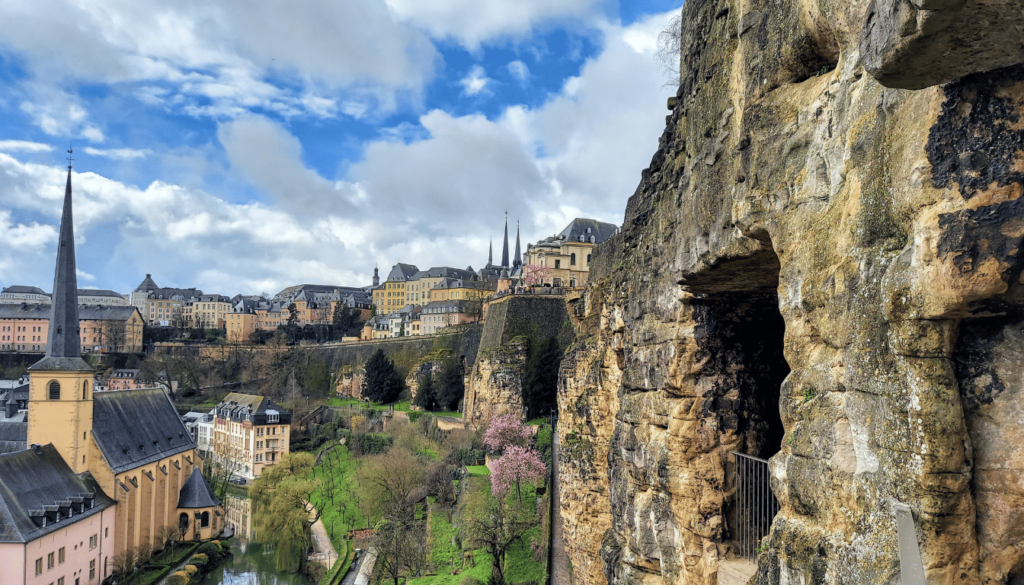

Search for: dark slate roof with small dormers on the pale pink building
xmin=0 ymin=445 xmax=114 ymax=543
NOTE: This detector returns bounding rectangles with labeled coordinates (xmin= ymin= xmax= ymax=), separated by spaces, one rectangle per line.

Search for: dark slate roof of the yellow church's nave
xmin=92 ymin=388 xmax=196 ymax=473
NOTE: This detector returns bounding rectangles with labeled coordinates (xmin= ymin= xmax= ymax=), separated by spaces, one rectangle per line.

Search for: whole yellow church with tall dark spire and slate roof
xmin=27 ymin=170 xmax=219 ymax=561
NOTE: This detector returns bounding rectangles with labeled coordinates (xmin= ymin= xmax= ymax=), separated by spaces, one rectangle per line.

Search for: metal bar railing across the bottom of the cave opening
xmin=733 ymin=452 xmax=779 ymax=562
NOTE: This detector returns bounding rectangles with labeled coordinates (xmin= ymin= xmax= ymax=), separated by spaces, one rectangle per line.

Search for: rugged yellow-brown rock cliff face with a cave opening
xmin=559 ymin=0 xmax=1024 ymax=585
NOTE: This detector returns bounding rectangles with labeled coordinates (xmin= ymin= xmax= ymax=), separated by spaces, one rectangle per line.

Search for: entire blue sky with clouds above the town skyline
xmin=0 ymin=0 xmax=681 ymax=295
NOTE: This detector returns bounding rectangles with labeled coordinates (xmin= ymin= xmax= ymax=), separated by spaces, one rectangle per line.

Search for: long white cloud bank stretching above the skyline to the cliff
xmin=0 ymin=8 xmax=669 ymax=294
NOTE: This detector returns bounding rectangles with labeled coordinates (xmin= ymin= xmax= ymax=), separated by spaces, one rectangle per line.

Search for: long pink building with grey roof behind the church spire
xmin=0 ymin=303 xmax=144 ymax=353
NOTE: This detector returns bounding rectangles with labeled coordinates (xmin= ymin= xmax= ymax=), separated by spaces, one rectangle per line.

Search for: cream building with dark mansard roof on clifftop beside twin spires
xmin=521 ymin=218 xmax=618 ymax=288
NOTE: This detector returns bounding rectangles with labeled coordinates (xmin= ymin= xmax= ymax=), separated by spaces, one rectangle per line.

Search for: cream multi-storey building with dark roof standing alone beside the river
xmin=213 ymin=392 xmax=292 ymax=480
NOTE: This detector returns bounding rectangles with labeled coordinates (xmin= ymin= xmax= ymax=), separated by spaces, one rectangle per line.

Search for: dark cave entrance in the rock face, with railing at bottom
xmin=681 ymin=244 xmax=790 ymax=561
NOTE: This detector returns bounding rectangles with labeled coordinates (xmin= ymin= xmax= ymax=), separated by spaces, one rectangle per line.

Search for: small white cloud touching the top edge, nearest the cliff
xmin=385 ymin=0 xmax=610 ymax=49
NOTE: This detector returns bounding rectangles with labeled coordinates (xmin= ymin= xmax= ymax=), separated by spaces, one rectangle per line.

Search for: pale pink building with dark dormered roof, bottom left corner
xmin=0 ymin=445 xmax=117 ymax=585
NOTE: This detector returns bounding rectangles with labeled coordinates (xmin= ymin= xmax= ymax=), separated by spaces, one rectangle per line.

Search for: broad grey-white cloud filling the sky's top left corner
xmin=0 ymin=0 xmax=439 ymax=120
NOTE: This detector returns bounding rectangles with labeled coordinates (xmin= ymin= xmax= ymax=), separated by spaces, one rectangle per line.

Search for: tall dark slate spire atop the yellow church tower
xmin=46 ymin=165 xmax=82 ymax=358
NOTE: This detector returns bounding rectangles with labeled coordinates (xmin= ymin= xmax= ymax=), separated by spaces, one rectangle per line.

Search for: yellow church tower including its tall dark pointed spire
xmin=28 ymin=166 xmax=93 ymax=473
